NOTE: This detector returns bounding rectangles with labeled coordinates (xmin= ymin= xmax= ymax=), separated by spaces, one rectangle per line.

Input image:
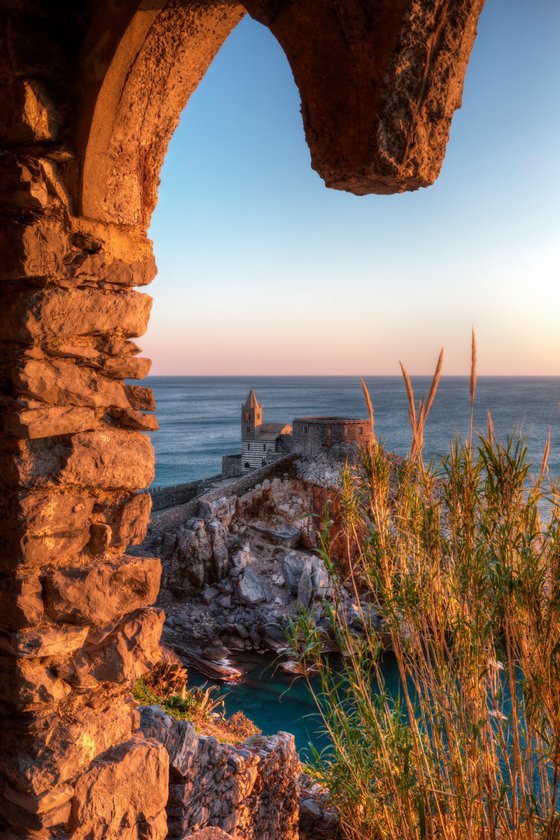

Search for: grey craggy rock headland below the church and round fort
xmin=137 ymin=445 xmax=357 ymax=680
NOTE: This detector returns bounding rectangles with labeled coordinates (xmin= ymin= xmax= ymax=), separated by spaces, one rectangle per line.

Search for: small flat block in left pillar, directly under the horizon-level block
xmin=4 ymin=406 xmax=99 ymax=440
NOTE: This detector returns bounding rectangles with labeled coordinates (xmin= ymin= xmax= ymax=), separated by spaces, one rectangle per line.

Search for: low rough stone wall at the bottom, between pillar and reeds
xmin=141 ymin=706 xmax=300 ymax=840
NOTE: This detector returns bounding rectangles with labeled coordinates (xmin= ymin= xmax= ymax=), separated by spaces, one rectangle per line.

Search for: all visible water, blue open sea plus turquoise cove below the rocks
xmin=147 ymin=376 xmax=560 ymax=759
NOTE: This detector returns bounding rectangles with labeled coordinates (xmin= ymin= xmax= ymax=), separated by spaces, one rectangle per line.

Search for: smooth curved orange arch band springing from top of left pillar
xmin=79 ymin=0 xmax=245 ymax=228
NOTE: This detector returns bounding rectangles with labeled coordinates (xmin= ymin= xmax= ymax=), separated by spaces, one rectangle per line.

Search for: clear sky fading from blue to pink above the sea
xmin=145 ymin=0 xmax=560 ymax=375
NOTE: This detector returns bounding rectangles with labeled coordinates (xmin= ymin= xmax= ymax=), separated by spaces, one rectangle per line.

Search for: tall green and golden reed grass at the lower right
xmin=291 ymin=356 xmax=560 ymax=840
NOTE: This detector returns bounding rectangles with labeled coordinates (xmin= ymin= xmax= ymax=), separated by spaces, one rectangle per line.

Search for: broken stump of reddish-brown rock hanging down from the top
xmin=244 ymin=0 xmax=484 ymax=195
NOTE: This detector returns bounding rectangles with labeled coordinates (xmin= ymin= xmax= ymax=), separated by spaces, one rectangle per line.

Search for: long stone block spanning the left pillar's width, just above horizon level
xmin=0 ymin=287 xmax=152 ymax=342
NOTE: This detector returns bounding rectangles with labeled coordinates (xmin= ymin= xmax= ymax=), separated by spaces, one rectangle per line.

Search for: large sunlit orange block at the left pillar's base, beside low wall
xmin=70 ymin=738 xmax=169 ymax=840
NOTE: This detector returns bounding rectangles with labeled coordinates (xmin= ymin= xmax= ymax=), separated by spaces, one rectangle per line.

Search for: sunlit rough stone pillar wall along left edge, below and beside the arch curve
xmin=0 ymin=3 xmax=172 ymax=840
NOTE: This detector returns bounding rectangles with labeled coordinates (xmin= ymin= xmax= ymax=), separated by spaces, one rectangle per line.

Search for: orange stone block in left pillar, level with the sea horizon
xmin=12 ymin=359 xmax=129 ymax=412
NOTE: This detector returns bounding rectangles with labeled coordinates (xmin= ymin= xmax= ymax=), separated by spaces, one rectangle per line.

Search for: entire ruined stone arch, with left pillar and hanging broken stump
xmin=0 ymin=0 xmax=483 ymax=840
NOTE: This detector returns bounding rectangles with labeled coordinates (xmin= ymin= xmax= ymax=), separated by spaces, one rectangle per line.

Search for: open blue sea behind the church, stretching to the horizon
xmin=147 ymin=376 xmax=560 ymax=486
